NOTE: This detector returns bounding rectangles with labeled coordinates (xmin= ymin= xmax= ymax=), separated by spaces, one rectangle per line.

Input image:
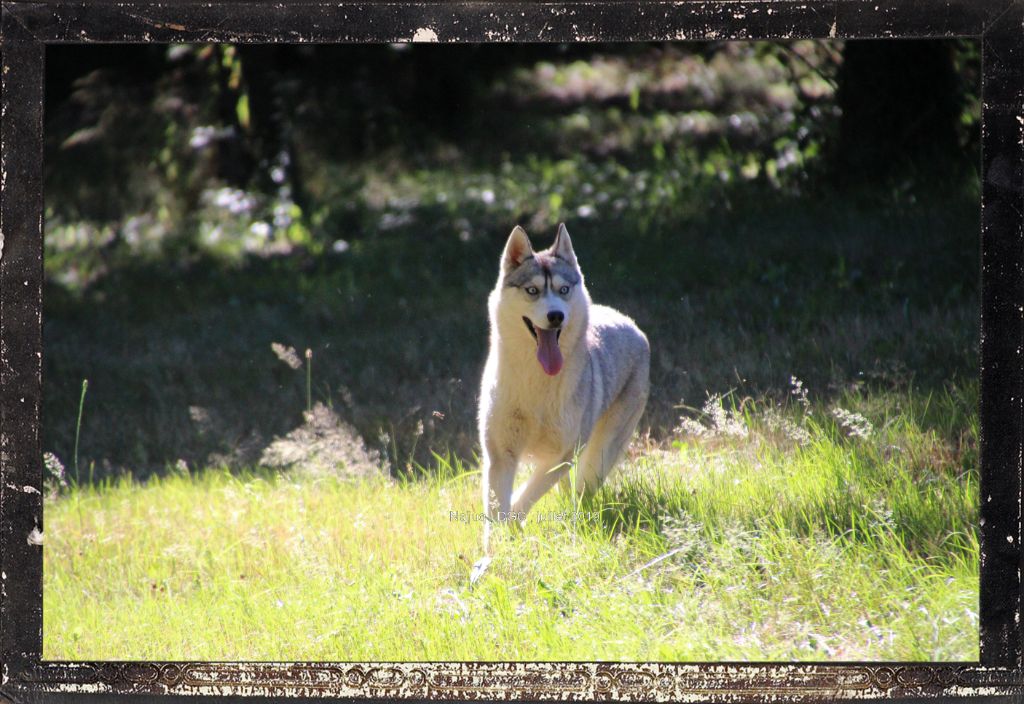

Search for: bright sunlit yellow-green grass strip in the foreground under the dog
xmin=43 ymin=385 xmax=978 ymax=660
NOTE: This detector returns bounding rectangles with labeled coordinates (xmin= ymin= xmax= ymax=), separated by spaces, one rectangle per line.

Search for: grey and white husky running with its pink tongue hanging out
xmin=479 ymin=224 xmax=650 ymax=549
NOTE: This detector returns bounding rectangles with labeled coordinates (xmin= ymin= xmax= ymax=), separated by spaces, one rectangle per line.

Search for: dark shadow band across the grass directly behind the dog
xmin=43 ymin=180 xmax=978 ymax=477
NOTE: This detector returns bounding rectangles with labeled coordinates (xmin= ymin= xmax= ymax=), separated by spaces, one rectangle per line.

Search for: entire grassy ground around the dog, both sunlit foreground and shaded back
xmin=43 ymin=44 xmax=979 ymax=660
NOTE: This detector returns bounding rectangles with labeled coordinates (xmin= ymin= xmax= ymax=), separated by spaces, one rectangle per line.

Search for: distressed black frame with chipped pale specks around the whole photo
xmin=0 ymin=0 xmax=1024 ymax=702
